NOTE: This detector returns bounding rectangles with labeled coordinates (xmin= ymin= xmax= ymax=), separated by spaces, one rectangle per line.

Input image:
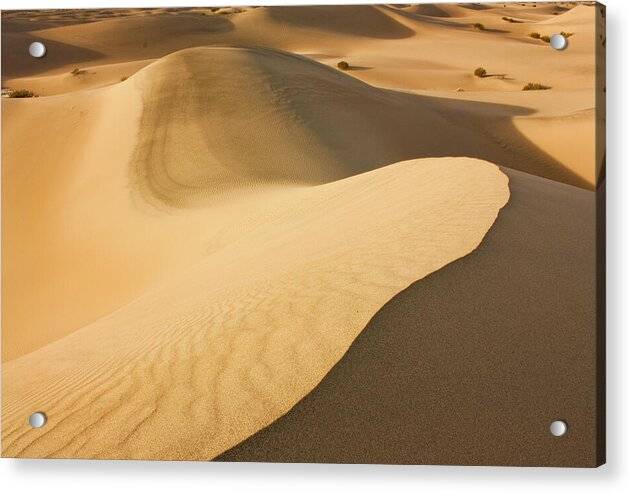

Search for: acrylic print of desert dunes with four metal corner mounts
xmin=2 ymin=2 xmax=605 ymax=467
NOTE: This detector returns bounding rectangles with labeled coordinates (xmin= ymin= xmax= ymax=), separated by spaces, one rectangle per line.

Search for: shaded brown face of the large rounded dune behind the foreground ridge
xmin=128 ymin=47 xmax=584 ymax=207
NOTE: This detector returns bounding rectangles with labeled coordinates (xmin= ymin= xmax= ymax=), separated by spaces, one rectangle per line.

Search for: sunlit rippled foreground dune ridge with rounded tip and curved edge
xmin=2 ymin=158 xmax=509 ymax=460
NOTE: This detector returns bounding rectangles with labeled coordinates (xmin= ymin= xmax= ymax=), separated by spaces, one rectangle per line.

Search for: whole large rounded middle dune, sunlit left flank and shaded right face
xmin=3 ymin=43 xmax=591 ymax=359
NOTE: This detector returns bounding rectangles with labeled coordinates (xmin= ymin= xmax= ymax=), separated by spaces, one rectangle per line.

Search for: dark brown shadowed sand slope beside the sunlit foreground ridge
xmin=219 ymin=170 xmax=599 ymax=467
